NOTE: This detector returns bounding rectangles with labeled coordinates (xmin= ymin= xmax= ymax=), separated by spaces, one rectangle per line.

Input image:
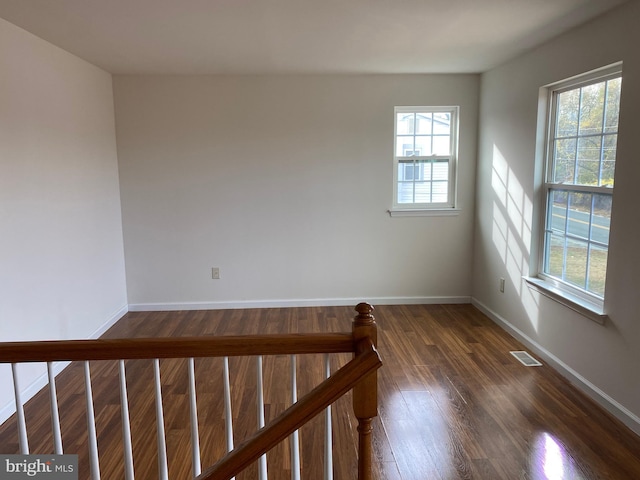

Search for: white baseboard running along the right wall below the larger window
xmin=471 ymin=298 xmax=640 ymax=435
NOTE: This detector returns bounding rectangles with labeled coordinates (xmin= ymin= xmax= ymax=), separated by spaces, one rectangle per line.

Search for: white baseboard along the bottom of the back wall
xmin=129 ymin=296 xmax=471 ymax=312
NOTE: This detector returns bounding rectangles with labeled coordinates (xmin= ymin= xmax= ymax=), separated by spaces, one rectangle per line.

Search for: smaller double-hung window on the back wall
xmin=393 ymin=107 xmax=458 ymax=209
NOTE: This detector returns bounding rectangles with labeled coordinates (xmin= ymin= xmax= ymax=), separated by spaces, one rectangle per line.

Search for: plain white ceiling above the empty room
xmin=0 ymin=0 xmax=625 ymax=74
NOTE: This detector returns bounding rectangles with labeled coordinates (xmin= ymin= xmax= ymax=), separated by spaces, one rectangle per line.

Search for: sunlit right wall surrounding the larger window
xmin=473 ymin=2 xmax=640 ymax=433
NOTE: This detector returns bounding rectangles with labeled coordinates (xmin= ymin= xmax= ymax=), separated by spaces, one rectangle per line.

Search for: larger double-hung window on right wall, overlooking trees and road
xmin=539 ymin=67 xmax=622 ymax=309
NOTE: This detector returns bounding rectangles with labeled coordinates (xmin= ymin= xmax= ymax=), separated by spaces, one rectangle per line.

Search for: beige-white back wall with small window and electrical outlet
xmin=114 ymin=75 xmax=479 ymax=309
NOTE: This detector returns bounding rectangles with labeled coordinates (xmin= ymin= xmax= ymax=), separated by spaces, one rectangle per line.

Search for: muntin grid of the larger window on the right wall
xmin=539 ymin=67 xmax=622 ymax=305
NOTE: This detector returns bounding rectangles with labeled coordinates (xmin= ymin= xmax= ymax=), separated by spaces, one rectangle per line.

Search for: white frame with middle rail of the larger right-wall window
xmin=526 ymin=63 xmax=622 ymax=323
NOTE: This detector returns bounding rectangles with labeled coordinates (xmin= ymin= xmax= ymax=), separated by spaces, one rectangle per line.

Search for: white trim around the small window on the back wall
xmin=388 ymin=106 xmax=460 ymax=213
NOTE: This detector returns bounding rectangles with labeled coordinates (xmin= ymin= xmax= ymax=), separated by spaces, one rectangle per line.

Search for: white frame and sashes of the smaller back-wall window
xmin=389 ymin=106 xmax=460 ymax=216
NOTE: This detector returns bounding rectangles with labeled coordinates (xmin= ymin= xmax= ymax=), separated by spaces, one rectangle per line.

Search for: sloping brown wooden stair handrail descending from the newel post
xmin=196 ymin=339 xmax=382 ymax=480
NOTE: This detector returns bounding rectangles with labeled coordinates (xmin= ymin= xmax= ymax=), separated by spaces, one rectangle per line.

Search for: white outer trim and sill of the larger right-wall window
xmin=524 ymin=62 xmax=622 ymax=324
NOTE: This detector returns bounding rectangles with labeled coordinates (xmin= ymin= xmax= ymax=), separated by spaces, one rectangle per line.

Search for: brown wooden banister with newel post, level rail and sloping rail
xmin=0 ymin=303 xmax=382 ymax=480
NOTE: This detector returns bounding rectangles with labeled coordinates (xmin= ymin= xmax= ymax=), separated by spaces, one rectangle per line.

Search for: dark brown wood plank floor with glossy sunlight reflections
xmin=0 ymin=305 xmax=640 ymax=480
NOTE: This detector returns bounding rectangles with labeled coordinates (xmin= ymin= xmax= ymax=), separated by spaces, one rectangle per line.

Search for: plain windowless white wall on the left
xmin=0 ymin=19 xmax=127 ymax=421
